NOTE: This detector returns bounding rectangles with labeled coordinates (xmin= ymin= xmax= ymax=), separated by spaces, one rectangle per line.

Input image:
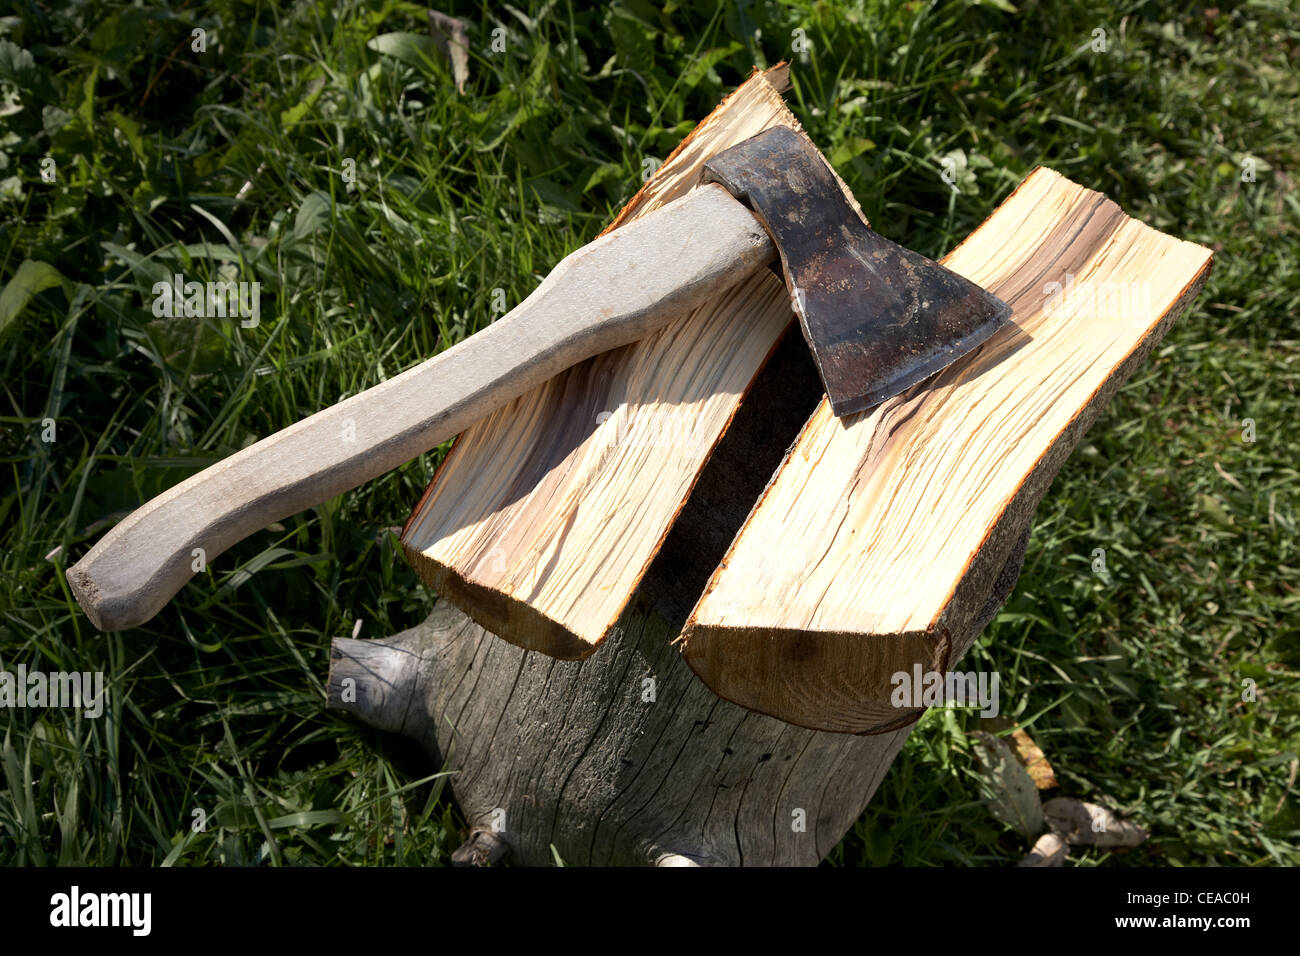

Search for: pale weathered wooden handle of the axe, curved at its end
xmin=68 ymin=186 xmax=776 ymax=631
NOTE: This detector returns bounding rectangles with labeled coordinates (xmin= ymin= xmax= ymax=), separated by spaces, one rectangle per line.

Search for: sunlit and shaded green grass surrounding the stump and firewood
xmin=0 ymin=0 xmax=1300 ymax=865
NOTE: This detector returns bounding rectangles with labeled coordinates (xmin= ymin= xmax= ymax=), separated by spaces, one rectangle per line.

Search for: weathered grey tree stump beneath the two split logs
xmin=328 ymin=509 xmax=1028 ymax=866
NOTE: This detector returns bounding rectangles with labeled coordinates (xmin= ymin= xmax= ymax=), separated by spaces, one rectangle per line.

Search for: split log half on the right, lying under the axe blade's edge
xmin=684 ymin=169 xmax=1212 ymax=732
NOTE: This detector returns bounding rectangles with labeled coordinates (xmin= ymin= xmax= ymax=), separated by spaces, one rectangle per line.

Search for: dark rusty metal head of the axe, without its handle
xmin=705 ymin=126 xmax=1011 ymax=416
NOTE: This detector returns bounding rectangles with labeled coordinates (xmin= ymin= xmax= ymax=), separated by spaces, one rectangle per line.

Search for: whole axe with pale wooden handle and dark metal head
xmin=68 ymin=126 xmax=1011 ymax=631
